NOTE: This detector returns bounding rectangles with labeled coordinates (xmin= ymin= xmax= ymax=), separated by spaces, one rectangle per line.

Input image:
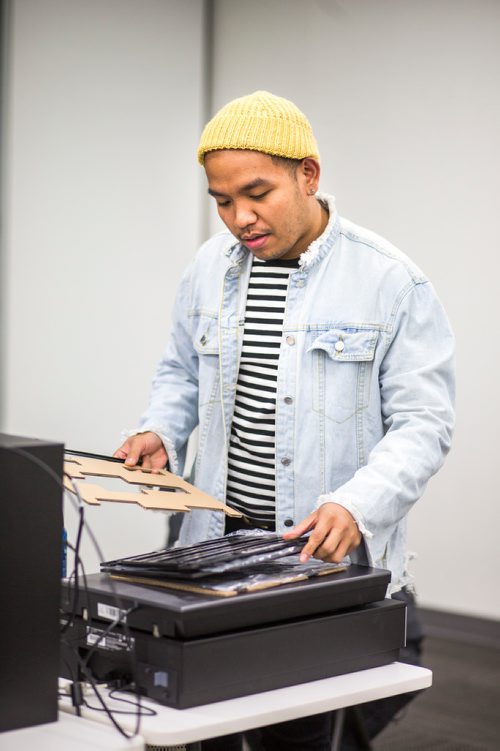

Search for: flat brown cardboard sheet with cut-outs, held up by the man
xmin=64 ymin=454 xmax=241 ymax=516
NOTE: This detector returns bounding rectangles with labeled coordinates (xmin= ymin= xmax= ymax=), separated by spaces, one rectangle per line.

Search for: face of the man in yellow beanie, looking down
xmin=205 ymin=150 xmax=319 ymax=261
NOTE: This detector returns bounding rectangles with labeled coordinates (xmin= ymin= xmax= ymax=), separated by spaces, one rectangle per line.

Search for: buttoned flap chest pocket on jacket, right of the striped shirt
xmin=307 ymin=327 xmax=379 ymax=423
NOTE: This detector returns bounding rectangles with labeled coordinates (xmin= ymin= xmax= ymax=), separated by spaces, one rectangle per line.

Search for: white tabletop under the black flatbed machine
xmin=60 ymin=662 xmax=432 ymax=751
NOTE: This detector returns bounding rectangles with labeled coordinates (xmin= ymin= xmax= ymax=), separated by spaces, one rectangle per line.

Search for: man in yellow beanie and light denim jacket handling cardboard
xmin=115 ymin=92 xmax=453 ymax=749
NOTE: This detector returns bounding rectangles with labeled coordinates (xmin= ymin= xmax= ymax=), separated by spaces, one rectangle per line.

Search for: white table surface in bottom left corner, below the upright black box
xmin=0 ymin=712 xmax=144 ymax=751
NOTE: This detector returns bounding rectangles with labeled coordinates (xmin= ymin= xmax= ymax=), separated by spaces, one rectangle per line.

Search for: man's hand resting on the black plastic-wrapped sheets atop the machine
xmin=283 ymin=503 xmax=361 ymax=563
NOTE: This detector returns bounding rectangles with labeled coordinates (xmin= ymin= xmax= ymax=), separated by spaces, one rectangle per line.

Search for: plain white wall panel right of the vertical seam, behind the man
xmin=213 ymin=0 xmax=500 ymax=618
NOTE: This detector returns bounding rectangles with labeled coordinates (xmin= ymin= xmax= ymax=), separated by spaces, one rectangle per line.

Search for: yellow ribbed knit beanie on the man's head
xmin=198 ymin=91 xmax=319 ymax=164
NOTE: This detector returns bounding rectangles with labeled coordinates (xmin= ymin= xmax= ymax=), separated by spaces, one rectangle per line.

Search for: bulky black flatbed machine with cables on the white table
xmin=61 ymin=564 xmax=406 ymax=708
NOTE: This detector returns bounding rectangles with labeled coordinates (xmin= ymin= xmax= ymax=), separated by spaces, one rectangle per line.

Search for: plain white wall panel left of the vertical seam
xmin=2 ymin=0 xmax=203 ymax=570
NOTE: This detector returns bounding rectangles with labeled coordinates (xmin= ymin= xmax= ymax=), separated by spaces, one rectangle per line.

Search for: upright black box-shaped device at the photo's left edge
xmin=0 ymin=434 xmax=64 ymax=745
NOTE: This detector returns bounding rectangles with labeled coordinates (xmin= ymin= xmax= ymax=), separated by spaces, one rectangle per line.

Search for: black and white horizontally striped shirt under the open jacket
xmin=226 ymin=258 xmax=299 ymax=524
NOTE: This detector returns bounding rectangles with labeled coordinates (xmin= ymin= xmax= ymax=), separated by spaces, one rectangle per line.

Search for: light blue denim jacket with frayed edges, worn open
xmin=129 ymin=195 xmax=454 ymax=592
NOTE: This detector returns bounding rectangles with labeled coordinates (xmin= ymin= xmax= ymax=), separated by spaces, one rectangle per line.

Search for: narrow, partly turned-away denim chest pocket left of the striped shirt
xmin=192 ymin=314 xmax=220 ymax=407
